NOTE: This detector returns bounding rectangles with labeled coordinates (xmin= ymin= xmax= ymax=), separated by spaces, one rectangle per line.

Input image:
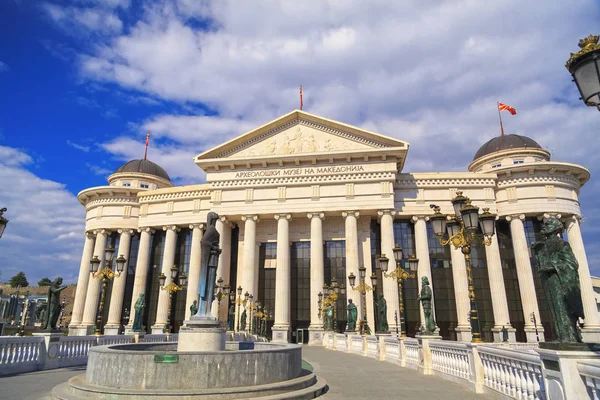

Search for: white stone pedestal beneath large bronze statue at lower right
xmin=537 ymin=342 xmax=600 ymax=400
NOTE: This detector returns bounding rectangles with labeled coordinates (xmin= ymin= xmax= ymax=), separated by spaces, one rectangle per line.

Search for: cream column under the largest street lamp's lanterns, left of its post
xmin=450 ymin=245 xmax=472 ymax=342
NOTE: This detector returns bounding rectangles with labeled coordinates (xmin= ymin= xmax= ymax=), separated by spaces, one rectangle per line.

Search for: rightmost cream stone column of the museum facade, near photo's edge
xmin=565 ymin=215 xmax=600 ymax=343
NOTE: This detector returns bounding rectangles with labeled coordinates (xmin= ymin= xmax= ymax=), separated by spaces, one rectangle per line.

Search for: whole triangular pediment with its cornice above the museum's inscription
xmin=195 ymin=110 xmax=409 ymax=169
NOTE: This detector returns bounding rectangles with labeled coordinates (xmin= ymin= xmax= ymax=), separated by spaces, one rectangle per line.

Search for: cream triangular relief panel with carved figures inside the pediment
xmin=233 ymin=125 xmax=371 ymax=157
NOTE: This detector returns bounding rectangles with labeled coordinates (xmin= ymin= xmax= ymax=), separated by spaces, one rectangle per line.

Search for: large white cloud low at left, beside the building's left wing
xmin=0 ymin=146 xmax=85 ymax=283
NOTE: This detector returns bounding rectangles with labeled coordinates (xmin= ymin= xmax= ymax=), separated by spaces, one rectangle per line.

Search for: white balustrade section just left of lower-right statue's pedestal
xmin=477 ymin=345 xmax=546 ymax=400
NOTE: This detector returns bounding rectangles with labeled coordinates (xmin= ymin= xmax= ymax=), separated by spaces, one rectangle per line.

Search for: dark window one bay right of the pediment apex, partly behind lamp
xmin=323 ymin=240 xmax=350 ymax=332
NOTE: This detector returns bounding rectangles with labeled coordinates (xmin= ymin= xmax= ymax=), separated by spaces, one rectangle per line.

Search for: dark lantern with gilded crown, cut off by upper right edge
xmin=565 ymin=35 xmax=600 ymax=111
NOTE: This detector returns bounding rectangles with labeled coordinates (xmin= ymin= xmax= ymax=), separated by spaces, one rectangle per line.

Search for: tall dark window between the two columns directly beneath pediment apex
xmin=290 ymin=242 xmax=317 ymax=332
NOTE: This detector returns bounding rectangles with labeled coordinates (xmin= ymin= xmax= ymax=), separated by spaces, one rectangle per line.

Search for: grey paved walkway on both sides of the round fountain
xmin=0 ymin=346 xmax=490 ymax=400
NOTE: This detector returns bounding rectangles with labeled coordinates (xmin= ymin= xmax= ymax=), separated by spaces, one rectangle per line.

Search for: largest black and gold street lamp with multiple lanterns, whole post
xmin=430 ymin=191 xmax=496 ymax=343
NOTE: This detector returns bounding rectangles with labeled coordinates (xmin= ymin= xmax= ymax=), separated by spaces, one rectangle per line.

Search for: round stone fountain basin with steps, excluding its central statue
xmin=52 ymin=342 xmax=326 ymax=400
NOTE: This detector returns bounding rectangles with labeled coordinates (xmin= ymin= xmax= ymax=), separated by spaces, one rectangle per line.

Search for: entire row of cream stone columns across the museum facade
xmin=71 ymin=210 xmax=600 ymax=342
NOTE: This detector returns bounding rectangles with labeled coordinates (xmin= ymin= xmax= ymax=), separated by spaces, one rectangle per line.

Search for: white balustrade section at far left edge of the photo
xmin=0 ymin=336 xmax=46 ymax=376
